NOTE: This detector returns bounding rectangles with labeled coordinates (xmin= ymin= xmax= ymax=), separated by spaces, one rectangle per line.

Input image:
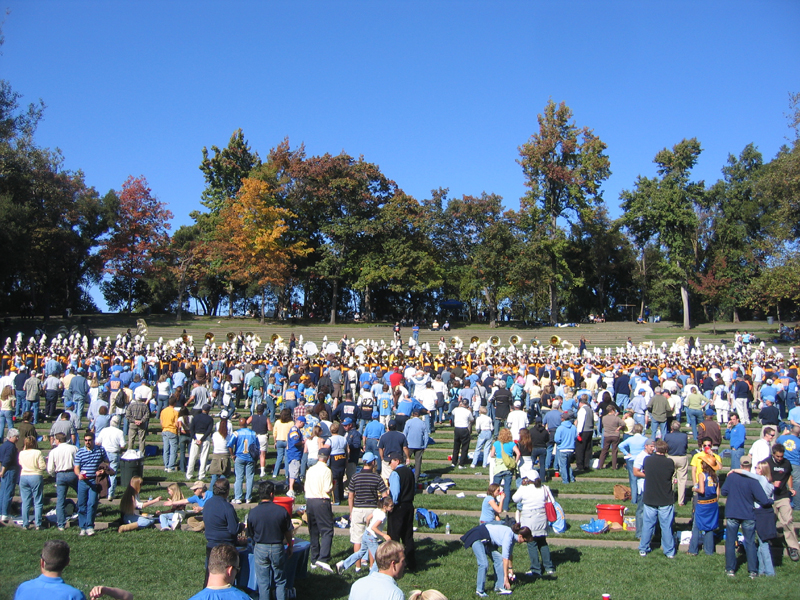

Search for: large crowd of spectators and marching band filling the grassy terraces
xmin=6 ymin=327 xmax=800 ymax=600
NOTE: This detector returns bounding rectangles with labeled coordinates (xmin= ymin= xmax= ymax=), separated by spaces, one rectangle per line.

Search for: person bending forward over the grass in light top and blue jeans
xmin=461 ymin=523 xmax=533 ymax=598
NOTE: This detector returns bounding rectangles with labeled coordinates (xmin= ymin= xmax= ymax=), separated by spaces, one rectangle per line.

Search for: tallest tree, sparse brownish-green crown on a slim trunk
xmin=518 ymin=99 xmax=611 ymax=323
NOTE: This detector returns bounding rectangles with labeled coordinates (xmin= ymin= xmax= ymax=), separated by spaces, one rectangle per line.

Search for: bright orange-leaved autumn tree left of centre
xmin=216 ymin=178 xmax=308 ymax=323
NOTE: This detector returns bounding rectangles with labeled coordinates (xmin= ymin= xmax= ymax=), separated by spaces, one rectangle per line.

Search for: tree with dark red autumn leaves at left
xmin=100 ymin=175 xmax=172 ymax=313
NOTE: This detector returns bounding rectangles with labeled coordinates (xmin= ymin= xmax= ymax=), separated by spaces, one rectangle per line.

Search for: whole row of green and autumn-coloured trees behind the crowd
xmin=0 ymin=69 xmax=800 ymax=328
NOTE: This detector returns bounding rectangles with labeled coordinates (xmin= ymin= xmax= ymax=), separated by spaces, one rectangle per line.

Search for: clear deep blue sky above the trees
xmin=0 ymin=0 xmax=800 ymax=308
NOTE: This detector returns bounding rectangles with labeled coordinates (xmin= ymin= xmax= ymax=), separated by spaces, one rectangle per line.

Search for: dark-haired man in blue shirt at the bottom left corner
xmin=14 ymin=540 xmax=133 ymax=600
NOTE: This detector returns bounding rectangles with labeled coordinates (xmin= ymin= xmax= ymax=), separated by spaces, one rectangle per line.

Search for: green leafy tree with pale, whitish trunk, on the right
xmin=620 ymin=138 xmax=704 ymax=329
